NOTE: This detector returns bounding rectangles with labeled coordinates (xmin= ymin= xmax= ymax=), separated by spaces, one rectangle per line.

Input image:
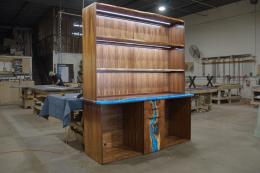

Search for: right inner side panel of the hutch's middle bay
xmin=169 ymin=49 xmax=185 ymax=70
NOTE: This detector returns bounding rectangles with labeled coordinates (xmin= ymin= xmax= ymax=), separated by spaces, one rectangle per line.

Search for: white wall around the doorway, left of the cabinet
xmin=53 ymin=52 xmax=82 ymax=81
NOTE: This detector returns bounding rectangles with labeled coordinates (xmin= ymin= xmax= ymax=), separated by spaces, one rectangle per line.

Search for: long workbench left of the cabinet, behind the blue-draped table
xmin=31 ymin=85 xmax=81 ymax=114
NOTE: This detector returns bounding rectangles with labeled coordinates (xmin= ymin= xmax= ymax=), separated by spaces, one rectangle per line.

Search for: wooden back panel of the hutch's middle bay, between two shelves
xmin=97 ymin=44 xmax=169 ymax=69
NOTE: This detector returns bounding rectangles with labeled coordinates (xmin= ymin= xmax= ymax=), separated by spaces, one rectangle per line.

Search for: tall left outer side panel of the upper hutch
xmin=82 ymin=4 xmax=96 ymax=100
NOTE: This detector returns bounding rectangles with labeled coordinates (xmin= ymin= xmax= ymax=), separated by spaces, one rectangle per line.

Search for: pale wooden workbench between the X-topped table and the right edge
xmin=212 ymin=84 xmax=242 ymax=104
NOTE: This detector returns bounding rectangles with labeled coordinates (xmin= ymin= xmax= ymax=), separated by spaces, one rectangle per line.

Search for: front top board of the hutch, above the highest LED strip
xmin=97 ymin=3 xmax=184 ymax=24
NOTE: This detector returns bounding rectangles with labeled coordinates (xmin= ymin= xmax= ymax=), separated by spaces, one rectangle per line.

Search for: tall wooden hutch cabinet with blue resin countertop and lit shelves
xmin=83 ymin=3 xmax=192 ymax=164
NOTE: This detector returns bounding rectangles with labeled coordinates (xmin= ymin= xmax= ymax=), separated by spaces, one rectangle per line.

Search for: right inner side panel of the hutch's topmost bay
xmin=169 ymin=25 xmax=185 ymax=45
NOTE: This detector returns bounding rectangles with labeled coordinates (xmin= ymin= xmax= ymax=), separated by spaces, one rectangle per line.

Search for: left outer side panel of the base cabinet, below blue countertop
xmin=83 ymin=102 xmax=103 ymax=163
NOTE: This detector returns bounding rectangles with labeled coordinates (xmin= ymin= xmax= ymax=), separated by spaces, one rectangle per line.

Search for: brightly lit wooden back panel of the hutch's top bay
xmin=97 ymin=16 xmax=169 ymax=43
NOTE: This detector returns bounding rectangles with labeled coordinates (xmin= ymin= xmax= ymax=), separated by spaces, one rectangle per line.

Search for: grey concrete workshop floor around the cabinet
xmin=0 ymin=104 xmax=260 ymax=173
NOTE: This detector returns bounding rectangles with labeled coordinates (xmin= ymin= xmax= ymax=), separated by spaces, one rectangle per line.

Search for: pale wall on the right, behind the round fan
xmin=183 ymin=0 xmax=260 ymax=97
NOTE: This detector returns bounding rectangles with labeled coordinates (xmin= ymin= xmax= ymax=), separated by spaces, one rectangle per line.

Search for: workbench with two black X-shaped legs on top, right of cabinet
xmin=185 ymin=86 xmax=217 ymax=112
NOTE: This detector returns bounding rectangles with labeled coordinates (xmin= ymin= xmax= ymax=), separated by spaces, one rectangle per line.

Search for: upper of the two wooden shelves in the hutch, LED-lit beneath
xmin=96 ymin=37 xmax=184 ymax=49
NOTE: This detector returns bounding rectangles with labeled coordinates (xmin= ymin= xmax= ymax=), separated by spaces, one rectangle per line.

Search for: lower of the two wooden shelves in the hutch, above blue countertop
xmin=97 ymin=68 xmax=184 ymax=73
